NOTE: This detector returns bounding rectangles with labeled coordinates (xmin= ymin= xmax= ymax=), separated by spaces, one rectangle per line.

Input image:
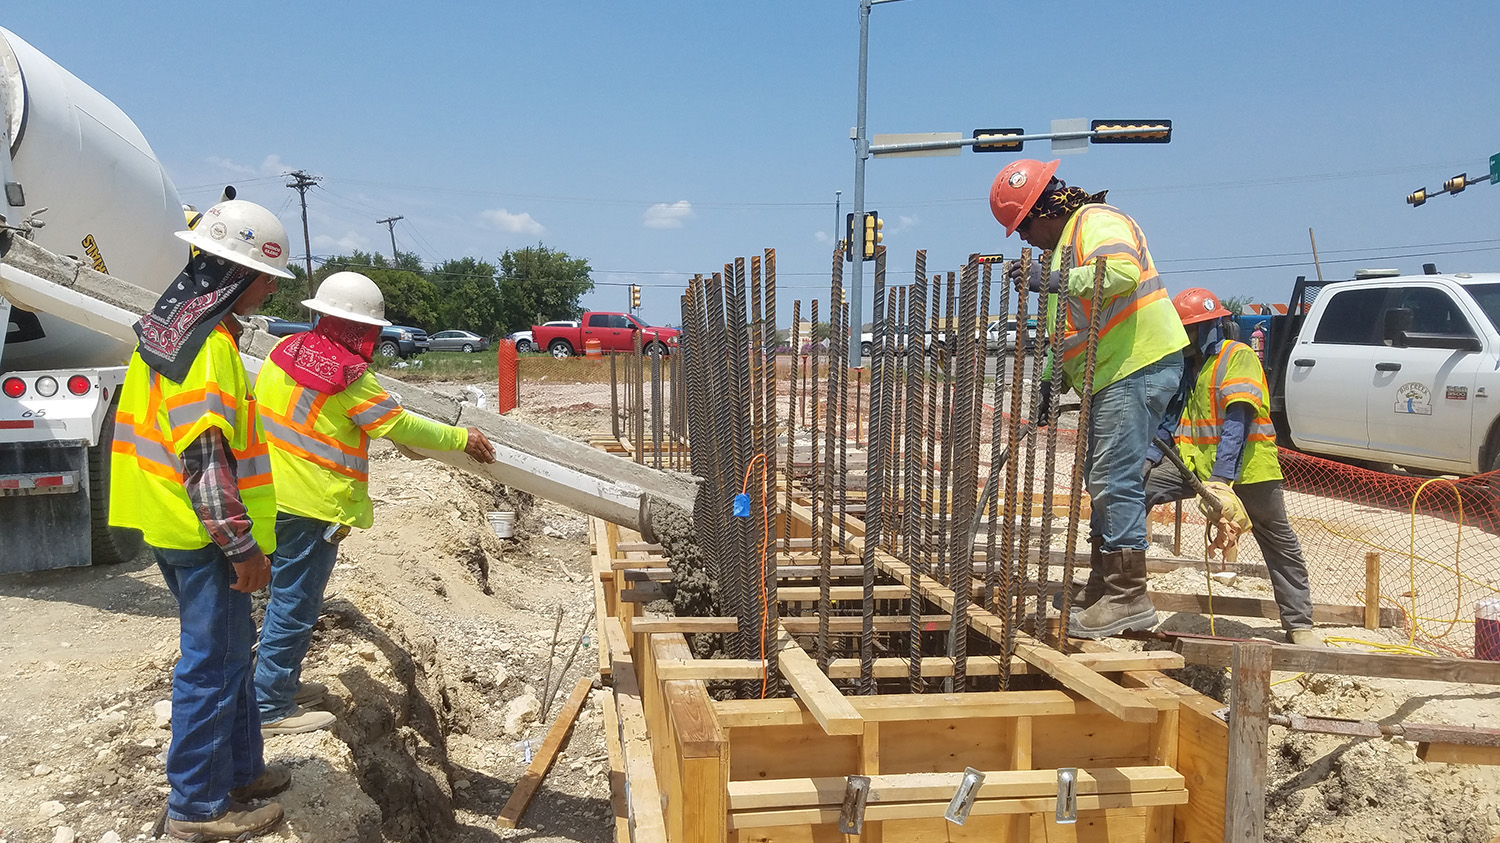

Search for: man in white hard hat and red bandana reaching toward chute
xmin=255 ymin=272 xmax=495 ymax=735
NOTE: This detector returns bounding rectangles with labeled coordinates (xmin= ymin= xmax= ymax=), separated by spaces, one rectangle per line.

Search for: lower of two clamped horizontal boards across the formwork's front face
xmin=729 ymin=773 xmax=1188 ymax=831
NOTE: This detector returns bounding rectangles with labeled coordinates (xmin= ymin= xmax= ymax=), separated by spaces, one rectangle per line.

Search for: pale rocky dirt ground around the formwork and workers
xmin=0 ymin=369 xmax=1500 ymax=843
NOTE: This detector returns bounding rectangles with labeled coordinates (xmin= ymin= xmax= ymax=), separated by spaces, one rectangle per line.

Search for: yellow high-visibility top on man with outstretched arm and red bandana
xmin=255 ymin=339 xmax=468 ymax=528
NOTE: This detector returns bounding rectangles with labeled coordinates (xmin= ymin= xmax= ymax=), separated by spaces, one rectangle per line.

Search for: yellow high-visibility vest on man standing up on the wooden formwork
xmin=1044 ymin=204 xmax=1188 ymax=392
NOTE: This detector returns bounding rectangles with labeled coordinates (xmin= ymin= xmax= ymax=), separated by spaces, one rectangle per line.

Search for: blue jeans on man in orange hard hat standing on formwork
xmin=1085 ymin=351 xmax=1182 ymax=552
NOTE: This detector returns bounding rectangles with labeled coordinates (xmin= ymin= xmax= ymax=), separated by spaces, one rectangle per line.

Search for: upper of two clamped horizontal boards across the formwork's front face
xmin=729 ymin=767 xmax=1187 ymax=812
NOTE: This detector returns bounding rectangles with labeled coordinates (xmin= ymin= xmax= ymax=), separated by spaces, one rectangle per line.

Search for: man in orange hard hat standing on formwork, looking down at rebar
xmin=990 ymin=161 xmax=1188 ymax=638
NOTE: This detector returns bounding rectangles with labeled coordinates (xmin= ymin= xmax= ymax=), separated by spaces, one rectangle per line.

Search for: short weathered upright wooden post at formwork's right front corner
xmin=1224 ymin=641 xmax=1271 ymax=843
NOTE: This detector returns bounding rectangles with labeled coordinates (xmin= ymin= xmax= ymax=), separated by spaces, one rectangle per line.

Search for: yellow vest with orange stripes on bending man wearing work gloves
xmin=1176 ymin=339 xmax=1281 ymax=483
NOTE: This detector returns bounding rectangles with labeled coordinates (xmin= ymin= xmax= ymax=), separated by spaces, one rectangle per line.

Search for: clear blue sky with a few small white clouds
xmin=0 ymin=0 xmax=1500 ymax=327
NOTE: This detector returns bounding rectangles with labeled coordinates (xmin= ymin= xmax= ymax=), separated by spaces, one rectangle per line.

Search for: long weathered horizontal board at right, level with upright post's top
xmin=1176 ymin=638 xmax=1500 ymax=686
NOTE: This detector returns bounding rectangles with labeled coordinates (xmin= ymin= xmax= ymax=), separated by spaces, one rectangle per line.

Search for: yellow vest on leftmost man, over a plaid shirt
xmin=110 ymin=326 xmax=276 ymax=554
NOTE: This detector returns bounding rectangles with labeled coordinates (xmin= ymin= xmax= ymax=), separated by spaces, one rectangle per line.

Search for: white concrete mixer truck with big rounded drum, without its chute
xmin=0 ymin=29 xmax=188 ymax=573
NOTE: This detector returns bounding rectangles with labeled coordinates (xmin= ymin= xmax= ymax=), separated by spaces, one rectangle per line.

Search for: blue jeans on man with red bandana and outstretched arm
xmin=255 ymin=513 xmax=339 ymax=714
